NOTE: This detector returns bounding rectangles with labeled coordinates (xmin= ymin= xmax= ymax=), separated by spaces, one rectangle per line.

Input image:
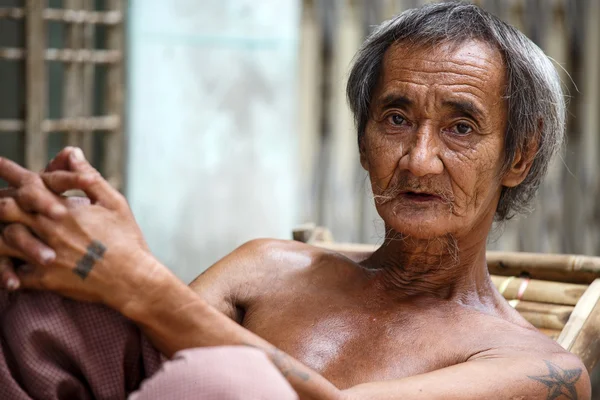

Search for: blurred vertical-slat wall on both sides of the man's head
xmin=300 ymin=0 xmax=600 ymax=254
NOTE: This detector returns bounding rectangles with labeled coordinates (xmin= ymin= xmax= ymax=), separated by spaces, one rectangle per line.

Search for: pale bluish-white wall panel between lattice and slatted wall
xmin=126 ymin=0 xmax=300 ymax=281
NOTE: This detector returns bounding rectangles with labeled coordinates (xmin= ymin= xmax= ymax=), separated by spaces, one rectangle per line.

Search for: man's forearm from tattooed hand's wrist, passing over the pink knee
xmin=120 ymin=264 xmax=342 ymax=400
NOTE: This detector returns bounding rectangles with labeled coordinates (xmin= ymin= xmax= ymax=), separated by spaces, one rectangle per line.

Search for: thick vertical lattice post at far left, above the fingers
xmin=25 ymin=0 xmax=48 ymax=171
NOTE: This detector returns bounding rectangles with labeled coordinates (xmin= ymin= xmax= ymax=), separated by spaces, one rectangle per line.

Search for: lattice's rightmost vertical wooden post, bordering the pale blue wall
xmin=102 ymin=0 xmax=125 ymax=190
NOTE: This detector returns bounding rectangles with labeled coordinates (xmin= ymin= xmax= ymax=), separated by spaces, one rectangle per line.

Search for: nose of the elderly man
xmin=400 ymin=127 xmax=444 ymax=176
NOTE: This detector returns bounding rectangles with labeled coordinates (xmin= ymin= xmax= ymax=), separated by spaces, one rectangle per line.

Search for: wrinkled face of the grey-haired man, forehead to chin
xmin=361 ymin=41 xmax=507 ymax=239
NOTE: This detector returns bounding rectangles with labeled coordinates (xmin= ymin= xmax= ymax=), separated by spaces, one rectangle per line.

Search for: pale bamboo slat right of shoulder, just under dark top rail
xmin=492 ymin=275 xmax=588 ymax=306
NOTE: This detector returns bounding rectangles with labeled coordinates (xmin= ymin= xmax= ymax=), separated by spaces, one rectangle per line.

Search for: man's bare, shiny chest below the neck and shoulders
xmin=243 ymin=298 xmax=470 ymax=388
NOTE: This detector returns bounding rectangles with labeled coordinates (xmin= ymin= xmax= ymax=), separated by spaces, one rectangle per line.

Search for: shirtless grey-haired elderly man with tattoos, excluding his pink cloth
xmin=0 ymin=3 xmax=590 ymax=399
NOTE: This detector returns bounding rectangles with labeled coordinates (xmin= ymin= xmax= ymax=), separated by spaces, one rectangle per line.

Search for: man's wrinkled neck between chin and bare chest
xmin=363 ymin=230 xmax=492 ymax=303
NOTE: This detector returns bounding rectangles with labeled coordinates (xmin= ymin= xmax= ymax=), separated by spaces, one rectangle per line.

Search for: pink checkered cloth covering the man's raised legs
xmin=0 ymin=291 xmax=297 ymax=400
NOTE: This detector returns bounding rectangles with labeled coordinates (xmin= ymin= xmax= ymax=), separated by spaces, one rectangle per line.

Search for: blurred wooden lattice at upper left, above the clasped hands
xmin=0 ymin=0 xmax=125 ymax=189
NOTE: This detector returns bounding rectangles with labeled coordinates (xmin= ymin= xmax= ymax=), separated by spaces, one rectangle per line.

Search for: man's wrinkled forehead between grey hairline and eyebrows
xmin=374 ymin=40 xmax=507 ymax=105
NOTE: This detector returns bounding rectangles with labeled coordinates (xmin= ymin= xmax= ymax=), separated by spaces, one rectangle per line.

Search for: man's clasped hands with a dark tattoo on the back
xmin=0 ymin=147 xmax=170 ymax=309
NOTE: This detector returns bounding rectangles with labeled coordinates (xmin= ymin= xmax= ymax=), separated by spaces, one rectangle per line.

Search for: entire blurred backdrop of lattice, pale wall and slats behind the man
xmin=0 ymin=0 xmax=600 ymax=281
